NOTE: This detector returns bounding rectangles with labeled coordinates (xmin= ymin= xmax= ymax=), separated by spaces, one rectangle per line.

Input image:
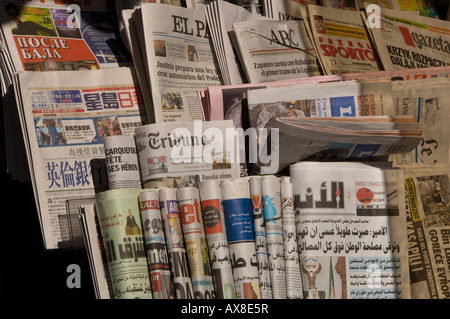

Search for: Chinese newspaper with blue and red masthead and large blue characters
xmin=16 ymin=68 xmax=147 ymax=249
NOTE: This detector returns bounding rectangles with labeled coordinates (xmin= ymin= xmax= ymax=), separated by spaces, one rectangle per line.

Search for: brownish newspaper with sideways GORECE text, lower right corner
xmin=405 ymin=167 xmax=450 ymax=299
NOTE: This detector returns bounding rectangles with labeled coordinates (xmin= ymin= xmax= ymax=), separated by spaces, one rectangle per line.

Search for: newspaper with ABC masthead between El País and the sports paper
xmin=233 ymin=20 xmax=321 ymax=83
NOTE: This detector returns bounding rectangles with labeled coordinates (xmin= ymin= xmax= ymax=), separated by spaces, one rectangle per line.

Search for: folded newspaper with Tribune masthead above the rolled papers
xmin=136 ymin=121 xmax=240 ymax=188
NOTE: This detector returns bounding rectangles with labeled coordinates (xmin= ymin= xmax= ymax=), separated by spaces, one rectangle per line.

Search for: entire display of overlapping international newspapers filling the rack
xmin=0 ymin=0 xmax=450 ymax=299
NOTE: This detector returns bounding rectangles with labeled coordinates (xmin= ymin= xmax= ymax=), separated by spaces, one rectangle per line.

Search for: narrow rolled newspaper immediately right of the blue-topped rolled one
xmin=249 ymin=176 xmax=272 ymax=299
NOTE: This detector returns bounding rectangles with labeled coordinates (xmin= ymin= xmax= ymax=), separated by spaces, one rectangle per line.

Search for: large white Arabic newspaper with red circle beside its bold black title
xmin=290 ymin=162 xmax=410 ymax=299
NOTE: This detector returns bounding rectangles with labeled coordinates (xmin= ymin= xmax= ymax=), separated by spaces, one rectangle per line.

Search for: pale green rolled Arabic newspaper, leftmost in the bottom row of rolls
xmin=95 ymin=189 xmax=152 ymax=299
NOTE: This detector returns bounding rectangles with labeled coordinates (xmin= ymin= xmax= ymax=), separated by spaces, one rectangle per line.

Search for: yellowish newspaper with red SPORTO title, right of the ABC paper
xmin=307 ymin=5 xmax=381 ymax=74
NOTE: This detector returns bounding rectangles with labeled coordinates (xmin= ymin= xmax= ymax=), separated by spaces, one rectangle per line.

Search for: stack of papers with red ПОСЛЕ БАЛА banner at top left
xmin=0 ymin=0 xmax=132 ymax=181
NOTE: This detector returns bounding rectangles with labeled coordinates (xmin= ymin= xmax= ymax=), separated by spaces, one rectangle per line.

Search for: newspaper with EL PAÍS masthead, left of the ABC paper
xmin=141 ymin=3 xmax=222 ymax=123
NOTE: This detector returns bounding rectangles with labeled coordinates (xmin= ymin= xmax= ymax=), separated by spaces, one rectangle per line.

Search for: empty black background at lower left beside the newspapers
xmin=0 ymin=92 xmax=95 ymax=300
